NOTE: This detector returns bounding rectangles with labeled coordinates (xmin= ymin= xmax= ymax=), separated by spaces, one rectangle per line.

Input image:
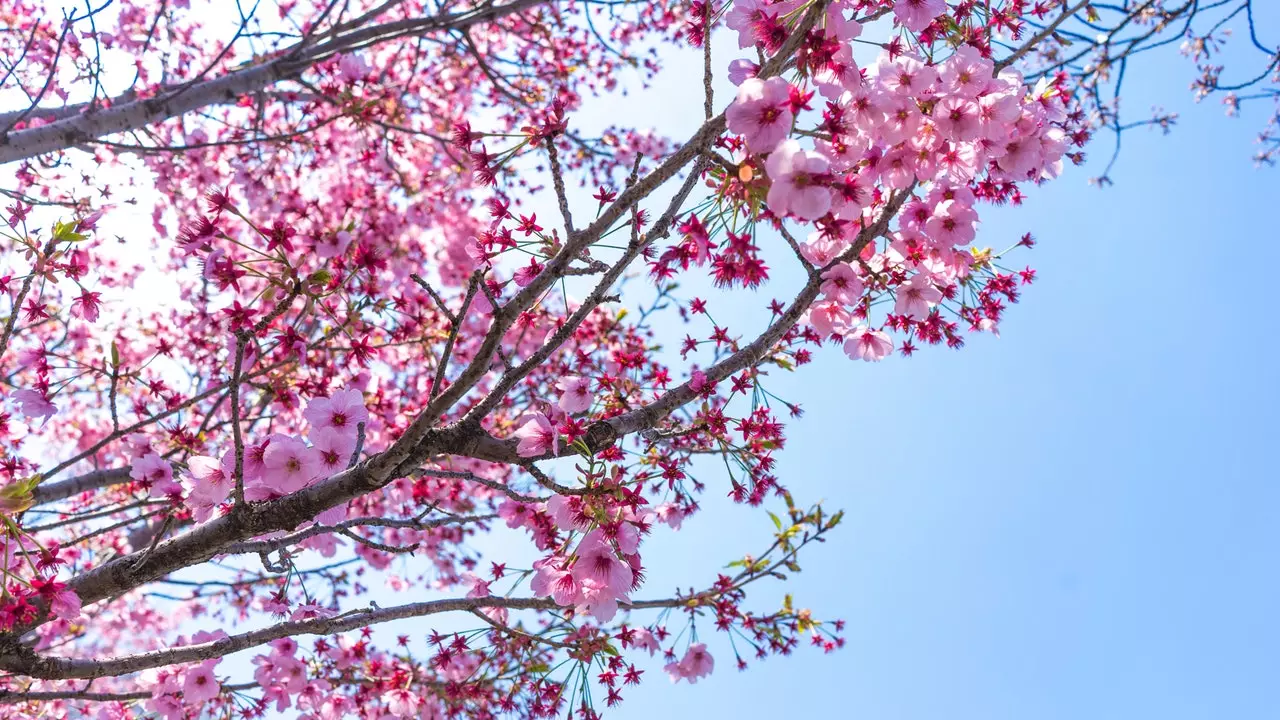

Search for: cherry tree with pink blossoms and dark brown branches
xmin=0 ymin=0 xmax=1280 ymax=719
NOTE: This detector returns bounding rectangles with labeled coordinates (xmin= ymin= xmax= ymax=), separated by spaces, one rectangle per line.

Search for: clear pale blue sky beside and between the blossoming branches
xmin=565 ymin=16 xmax=1280 ymax=720
